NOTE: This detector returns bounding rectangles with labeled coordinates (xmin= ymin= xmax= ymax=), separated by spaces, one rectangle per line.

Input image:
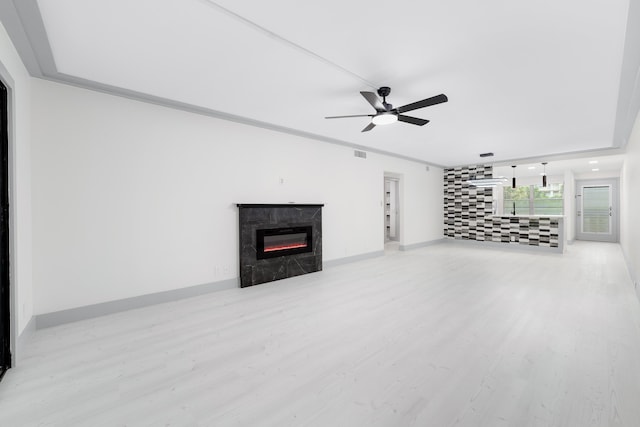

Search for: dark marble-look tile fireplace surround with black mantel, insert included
xmin=237 ymin=204 xmax=324 ymax=288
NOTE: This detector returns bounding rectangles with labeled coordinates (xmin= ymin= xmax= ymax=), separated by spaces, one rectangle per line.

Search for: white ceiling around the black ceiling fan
xmin=2 ymin=0 xmax=629 ymax=166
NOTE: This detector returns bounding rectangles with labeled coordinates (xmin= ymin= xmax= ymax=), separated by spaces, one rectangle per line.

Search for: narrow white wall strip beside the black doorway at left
xmin=0 ymin=24 xmax=33 ymax=338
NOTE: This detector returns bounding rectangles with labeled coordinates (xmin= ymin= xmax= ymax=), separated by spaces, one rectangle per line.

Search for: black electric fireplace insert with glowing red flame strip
xmin=256 ymin=226 xmax=313 ymax=259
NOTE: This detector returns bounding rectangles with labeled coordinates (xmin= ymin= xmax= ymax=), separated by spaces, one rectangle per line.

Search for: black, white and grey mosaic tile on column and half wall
xmin=444 ymin=165 xmax=561 ymax=248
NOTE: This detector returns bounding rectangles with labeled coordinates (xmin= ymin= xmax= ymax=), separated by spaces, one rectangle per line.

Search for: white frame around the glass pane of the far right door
xmin=576 ymin=178 xmax=620 ymax=243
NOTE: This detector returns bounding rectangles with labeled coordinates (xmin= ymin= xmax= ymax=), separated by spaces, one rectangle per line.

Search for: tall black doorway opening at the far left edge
xmin=0 ymin=81 xmax=11 ymax=379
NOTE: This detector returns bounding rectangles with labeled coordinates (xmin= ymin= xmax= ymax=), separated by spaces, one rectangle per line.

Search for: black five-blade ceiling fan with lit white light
xmin=325 ymin=86 xmax=449 ymax=132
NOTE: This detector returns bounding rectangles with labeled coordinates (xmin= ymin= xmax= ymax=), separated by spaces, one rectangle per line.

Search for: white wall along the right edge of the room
xmin=620 ymin=111 xmax=640 ymax=295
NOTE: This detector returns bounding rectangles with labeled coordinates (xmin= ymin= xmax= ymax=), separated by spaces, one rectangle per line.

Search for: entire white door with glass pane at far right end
xmin=576 ymin=179 xmax=619 ymax=242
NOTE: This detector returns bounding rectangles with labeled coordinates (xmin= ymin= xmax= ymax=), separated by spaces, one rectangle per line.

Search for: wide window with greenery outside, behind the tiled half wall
xmin=502 ymin=184 xmax=564 ymax=216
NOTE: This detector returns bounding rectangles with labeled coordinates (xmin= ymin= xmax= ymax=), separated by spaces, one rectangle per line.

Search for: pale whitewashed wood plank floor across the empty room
xmin=0 ymin=242 xmax=640 ymax=427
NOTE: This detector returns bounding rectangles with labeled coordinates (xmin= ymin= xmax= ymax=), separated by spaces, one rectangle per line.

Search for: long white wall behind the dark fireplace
xmin=32 ymin=80 xmax=443 ymax=314
